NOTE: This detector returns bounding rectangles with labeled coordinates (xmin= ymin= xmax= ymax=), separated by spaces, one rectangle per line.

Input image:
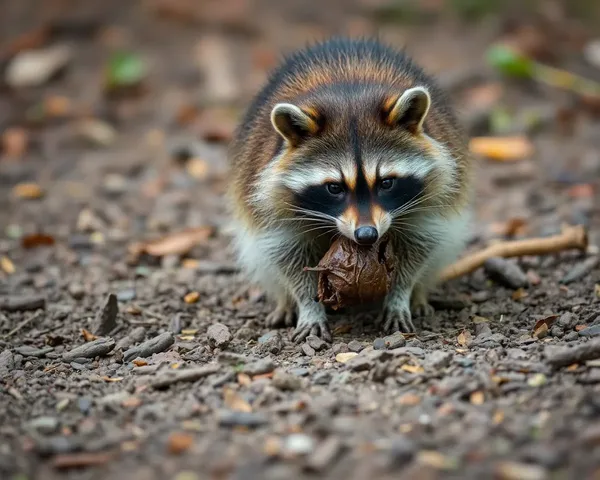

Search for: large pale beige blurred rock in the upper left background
xmin=5 ymin=45 xmax=72 ymax=88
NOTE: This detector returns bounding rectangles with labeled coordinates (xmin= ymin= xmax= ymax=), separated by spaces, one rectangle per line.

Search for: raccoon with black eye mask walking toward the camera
xmin=229 ymin=38 xmax=472 ymax=341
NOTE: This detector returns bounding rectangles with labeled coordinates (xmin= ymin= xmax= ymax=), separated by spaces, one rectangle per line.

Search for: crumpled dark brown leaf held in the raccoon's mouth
xmin=305 ymin=237 xmax=394 ymax=310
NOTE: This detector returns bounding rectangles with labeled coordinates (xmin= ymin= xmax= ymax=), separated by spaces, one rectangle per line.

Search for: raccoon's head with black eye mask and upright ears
xmin=257 ymin=86 xmax=457 ymax=245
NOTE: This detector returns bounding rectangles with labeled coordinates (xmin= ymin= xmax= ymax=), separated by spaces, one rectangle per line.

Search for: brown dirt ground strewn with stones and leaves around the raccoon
xmin=0 ymin=0 xmax=600 ymax=480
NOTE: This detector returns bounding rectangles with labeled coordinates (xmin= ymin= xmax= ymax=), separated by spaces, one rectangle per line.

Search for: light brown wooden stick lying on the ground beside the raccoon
xmin=440 ymin=225 xmax=588 ymax=282
